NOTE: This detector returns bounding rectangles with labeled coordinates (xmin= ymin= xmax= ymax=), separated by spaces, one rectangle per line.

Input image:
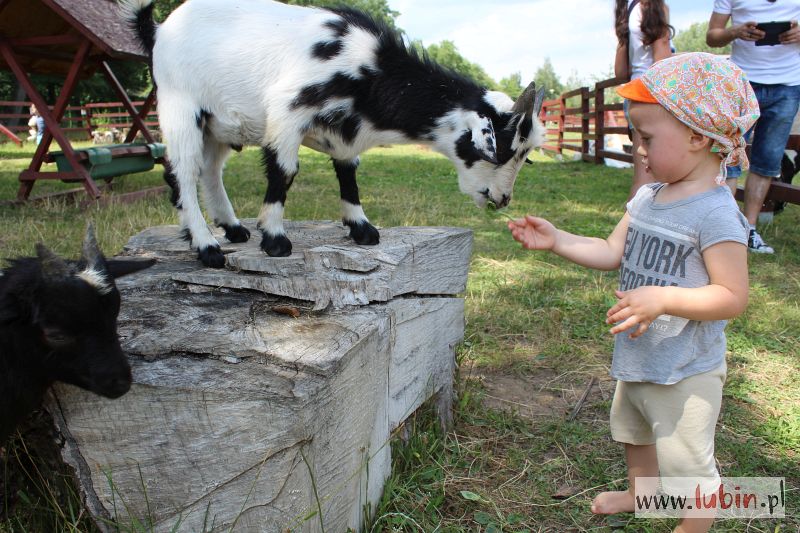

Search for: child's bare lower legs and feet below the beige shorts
xmin=592 ymin=444 xmax=714 ymax=533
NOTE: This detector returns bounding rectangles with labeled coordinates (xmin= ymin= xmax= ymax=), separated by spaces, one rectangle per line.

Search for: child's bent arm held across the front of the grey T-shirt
xmin=606 ymin=241 xmax=749 ymax=338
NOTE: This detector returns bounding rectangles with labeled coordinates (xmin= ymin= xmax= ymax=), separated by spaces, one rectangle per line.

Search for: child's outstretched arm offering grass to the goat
xmin=508 ymin=213 xmax=630 ymax=270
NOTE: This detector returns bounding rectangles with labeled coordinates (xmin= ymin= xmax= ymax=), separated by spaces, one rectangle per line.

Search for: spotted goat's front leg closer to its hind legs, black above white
xmin=258 ymin=144 xmax=299 ymax=257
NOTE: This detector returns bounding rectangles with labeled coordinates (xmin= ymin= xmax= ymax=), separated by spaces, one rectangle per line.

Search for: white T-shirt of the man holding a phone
xmin=714 ymin=0 xmax=800 ymax=85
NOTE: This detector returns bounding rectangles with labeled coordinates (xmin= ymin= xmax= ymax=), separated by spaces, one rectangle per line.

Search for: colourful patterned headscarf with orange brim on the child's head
xmin=617 ymin=52 xmax=761 ymax=185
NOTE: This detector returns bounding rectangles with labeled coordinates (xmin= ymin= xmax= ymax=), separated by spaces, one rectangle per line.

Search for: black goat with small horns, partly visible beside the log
xmin=0 ymin=226 xmax=153 ymax=445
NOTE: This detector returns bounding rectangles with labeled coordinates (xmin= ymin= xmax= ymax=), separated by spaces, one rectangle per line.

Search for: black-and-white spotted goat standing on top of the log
xmin=120 ymin=0 xmax=545 ymax=268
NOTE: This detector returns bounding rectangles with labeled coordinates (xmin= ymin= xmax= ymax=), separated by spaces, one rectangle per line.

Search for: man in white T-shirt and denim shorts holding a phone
xmin=706 ymin=0 xmax=800 ymax=254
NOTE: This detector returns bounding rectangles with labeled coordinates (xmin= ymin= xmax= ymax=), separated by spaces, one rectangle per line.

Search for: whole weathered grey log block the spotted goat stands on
xmin=48 ymin=222 xmax=471 ymax=532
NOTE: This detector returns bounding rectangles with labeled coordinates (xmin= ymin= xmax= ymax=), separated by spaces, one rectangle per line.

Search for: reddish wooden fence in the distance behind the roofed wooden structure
xmin=0 ymin=100 xmax=158 ymax=140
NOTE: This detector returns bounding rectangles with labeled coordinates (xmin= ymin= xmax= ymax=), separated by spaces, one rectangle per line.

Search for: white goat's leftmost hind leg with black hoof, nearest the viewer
xmin=159 ymin=94 xmax=225 ymax=268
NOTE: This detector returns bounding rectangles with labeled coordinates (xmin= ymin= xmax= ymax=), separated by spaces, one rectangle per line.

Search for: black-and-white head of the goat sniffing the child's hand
xmin=436 ymin=83 xmax=545 ymax=208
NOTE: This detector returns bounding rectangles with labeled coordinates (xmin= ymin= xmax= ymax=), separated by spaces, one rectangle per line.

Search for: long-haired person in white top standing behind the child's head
xmin=614 ymin=0 xmax=675 ymax=199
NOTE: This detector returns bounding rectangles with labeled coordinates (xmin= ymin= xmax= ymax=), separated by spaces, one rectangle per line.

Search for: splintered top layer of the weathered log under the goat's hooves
xmin=127 ymin=220 xmax=472 ymax=310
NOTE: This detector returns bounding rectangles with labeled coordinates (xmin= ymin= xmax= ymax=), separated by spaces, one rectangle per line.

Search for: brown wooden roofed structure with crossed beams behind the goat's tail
xmin=0 ymin=0 xmax=164 ymax=201
